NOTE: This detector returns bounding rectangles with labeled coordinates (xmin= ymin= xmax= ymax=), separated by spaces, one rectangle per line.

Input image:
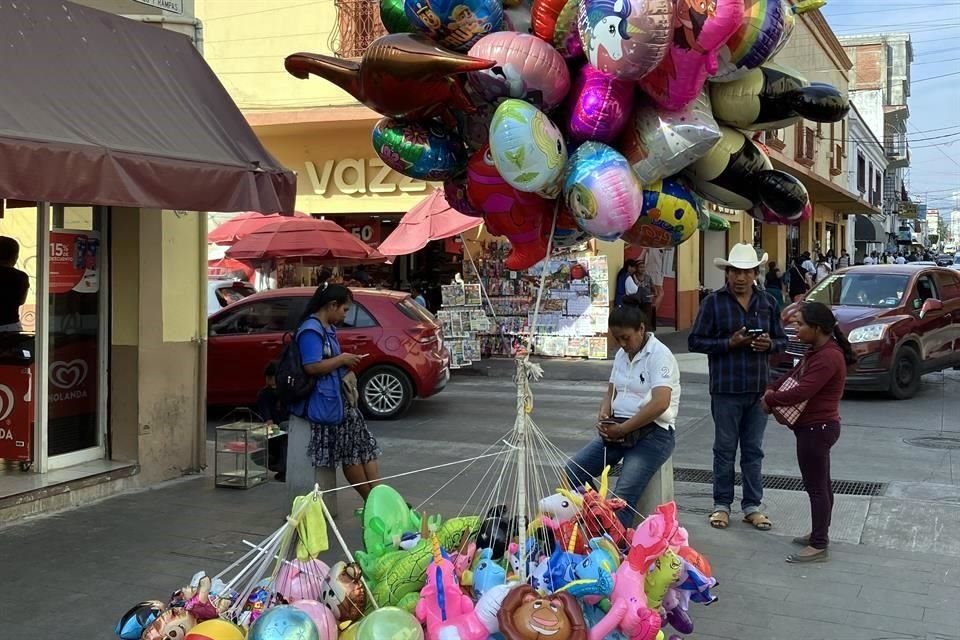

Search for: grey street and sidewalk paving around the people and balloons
xmin=0 ymin=368 xmax=960 ymax=640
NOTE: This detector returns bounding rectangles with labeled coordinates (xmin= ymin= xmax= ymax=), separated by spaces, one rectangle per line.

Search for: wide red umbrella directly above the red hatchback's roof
xmin=227 ymin=218 xmax=386 ymax=263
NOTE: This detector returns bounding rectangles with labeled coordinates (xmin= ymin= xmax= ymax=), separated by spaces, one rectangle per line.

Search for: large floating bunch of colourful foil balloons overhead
xmin=286 ymin=0 xmax=849 ymax=270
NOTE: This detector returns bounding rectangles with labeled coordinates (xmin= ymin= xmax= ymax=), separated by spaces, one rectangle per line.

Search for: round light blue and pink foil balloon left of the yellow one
xmin=563 ymin=142 xmax=643 ymax=240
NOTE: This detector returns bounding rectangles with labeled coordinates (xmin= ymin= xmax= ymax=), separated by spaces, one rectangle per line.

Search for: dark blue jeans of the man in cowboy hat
xmin=710 ymin=393 xmax=767 ymax=515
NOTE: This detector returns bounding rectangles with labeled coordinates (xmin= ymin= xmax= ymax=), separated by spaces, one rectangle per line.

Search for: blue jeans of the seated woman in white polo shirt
xmin=566 ymin=425 xmax=676 ymax=528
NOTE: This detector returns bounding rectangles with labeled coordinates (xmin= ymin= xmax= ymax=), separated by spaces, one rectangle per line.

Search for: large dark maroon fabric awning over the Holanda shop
xmin=0 ymin=0 xmax=296 ymax=213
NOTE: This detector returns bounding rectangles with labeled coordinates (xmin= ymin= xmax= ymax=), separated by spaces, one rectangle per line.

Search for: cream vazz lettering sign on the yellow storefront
xmin=305 ymin=158 xmax=427 ymax=196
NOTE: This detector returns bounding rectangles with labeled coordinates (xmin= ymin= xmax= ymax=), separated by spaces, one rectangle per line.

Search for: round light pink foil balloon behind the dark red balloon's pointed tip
xmin=468 ymin=31 xmax=570 ymax=111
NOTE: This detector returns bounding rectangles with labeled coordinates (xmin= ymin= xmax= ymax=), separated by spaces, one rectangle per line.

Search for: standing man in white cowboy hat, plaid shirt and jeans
xmin=688 ymin=244 xmax=787 ymax=531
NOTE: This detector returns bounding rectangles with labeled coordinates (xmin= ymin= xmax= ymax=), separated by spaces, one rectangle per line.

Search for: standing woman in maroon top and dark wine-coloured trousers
xmin=763 ymin=302 xmax=857 ymax=563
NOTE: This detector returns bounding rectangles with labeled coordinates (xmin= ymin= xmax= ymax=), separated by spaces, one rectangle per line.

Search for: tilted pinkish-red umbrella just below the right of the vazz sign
xmin=377 ymin=189 xmax=483 ymax=256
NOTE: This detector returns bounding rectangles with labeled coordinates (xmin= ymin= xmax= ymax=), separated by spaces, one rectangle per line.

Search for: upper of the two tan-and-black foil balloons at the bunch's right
xmin=710 ymin=63 xmax=850 ymax=131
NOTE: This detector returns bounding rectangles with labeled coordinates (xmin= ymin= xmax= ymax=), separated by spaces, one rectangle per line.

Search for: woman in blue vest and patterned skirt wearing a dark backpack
xmin=278 ymin=283 xmax=380 ymax=501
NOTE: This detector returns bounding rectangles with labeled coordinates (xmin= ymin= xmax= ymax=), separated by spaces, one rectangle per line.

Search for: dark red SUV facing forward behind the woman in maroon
xmin=771 ymin=264 xmax=960 ymax=399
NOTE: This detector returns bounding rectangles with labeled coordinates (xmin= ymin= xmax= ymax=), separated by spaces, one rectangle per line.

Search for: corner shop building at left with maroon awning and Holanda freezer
xmin=0 ymin=0 xmax=294 ymax=522
